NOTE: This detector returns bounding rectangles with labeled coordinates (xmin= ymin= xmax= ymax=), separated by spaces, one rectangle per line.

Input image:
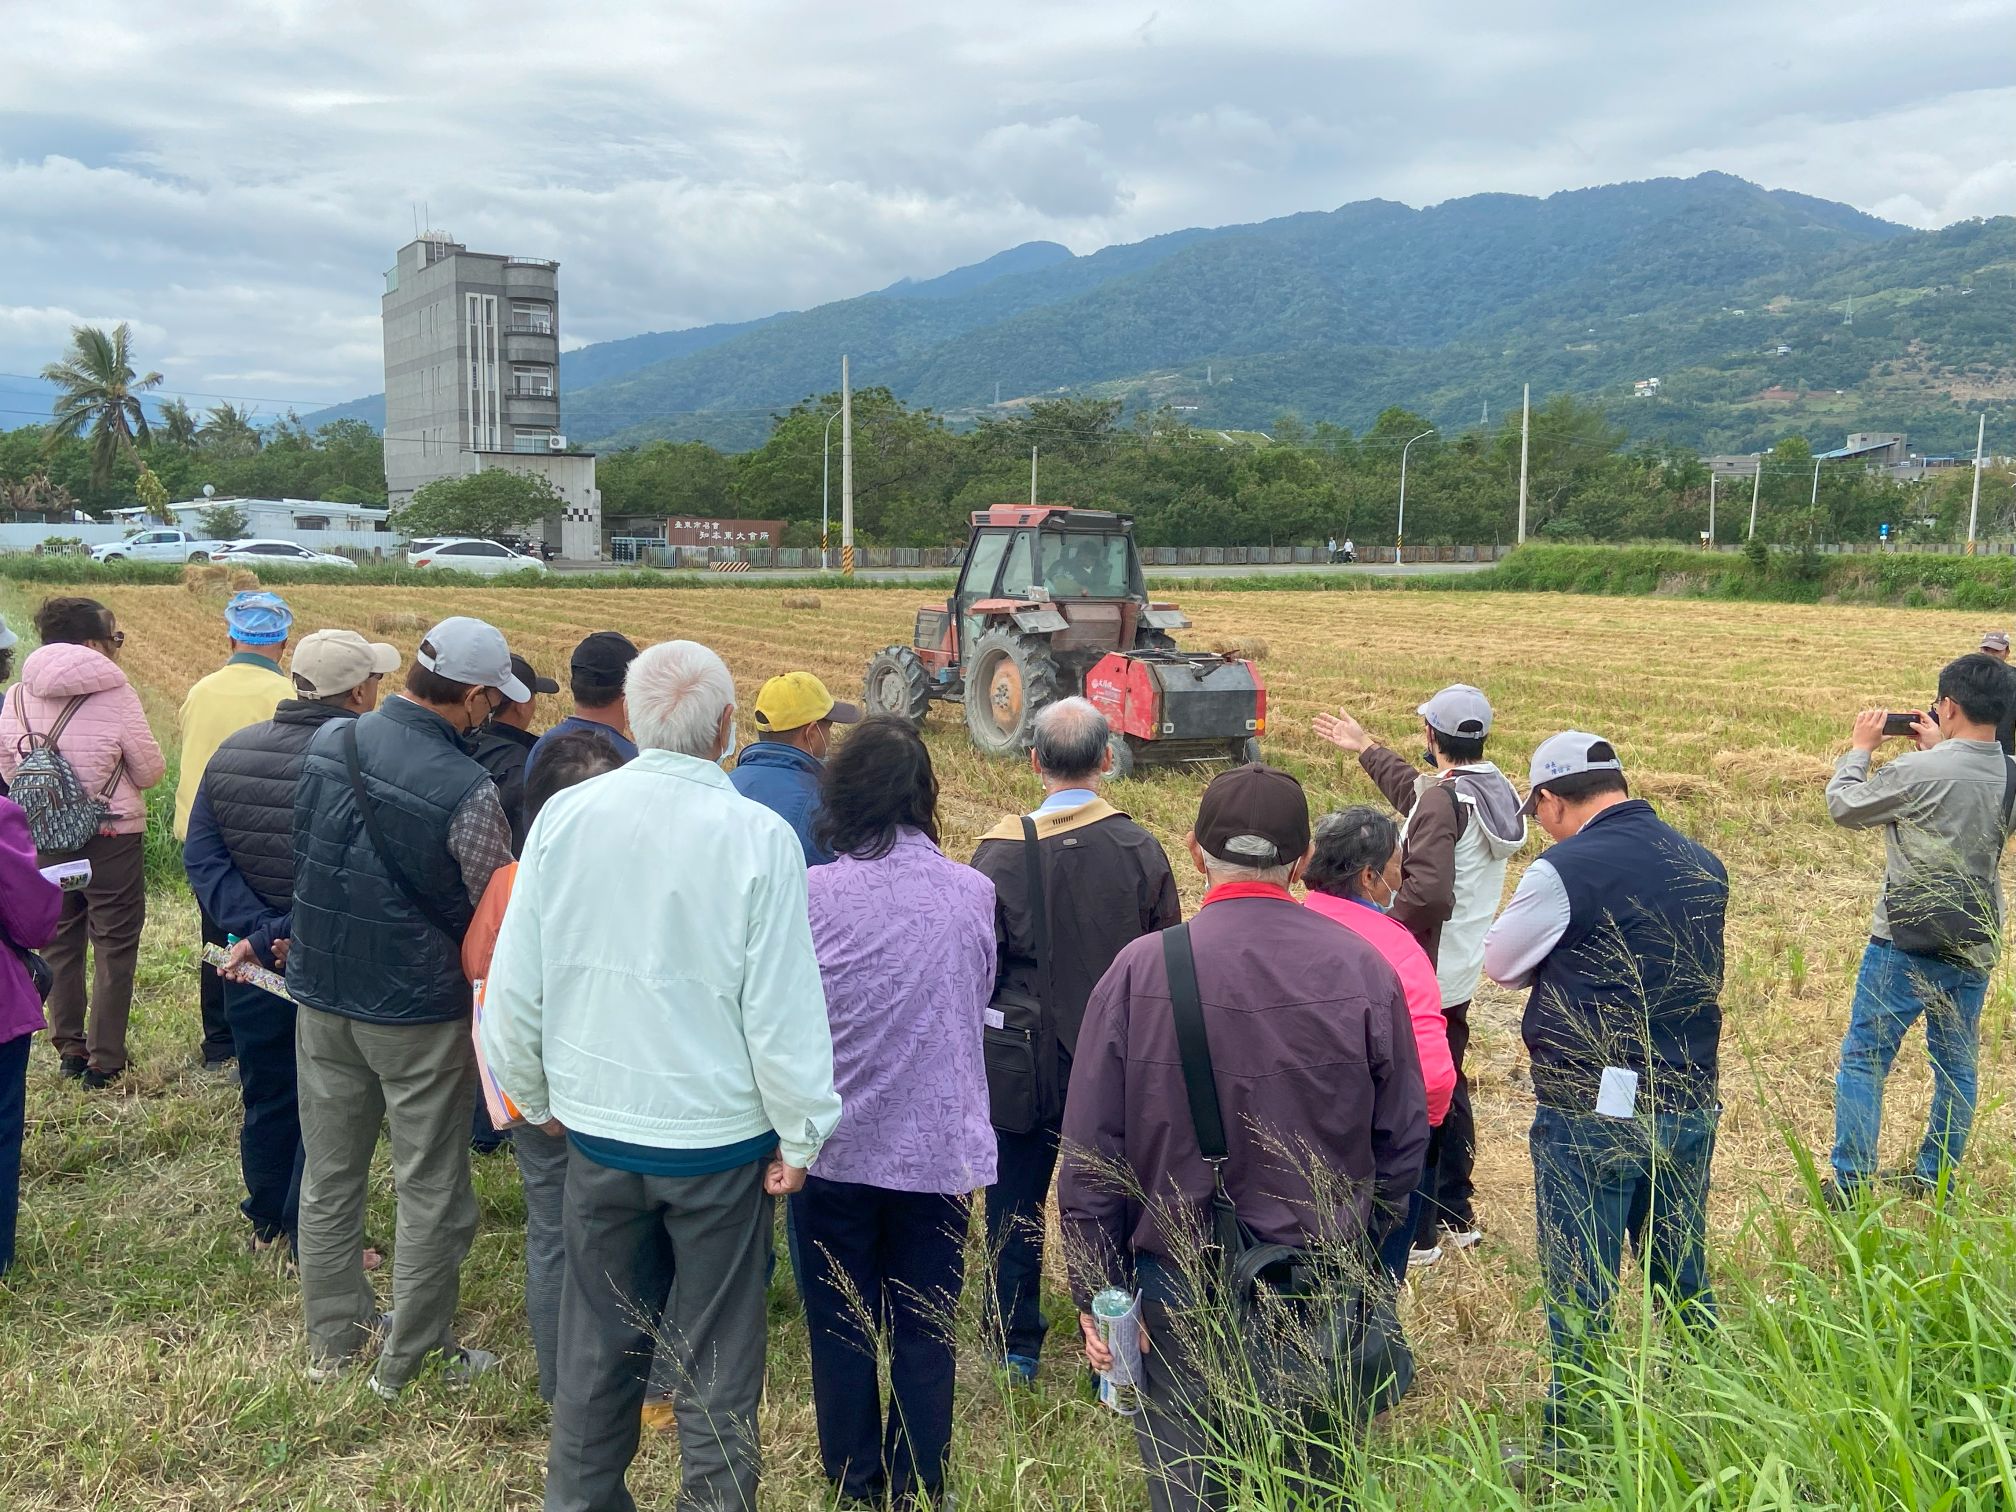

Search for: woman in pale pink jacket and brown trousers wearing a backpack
xmin=0 ymin=599 xmax=167 ymax=1087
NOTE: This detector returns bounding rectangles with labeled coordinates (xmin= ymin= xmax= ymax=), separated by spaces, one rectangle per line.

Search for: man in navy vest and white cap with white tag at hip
xmin=1484 ymin=730 xmax=1730 ymax=1423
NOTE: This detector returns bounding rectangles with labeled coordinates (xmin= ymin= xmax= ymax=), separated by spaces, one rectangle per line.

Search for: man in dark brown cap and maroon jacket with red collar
xmin=1058 ymin=764 xmax=1427 ymax=1512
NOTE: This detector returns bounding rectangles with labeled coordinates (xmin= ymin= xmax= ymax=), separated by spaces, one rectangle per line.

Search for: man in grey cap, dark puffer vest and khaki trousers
xmin=286 ymin=617 xmax=532 ymax=1397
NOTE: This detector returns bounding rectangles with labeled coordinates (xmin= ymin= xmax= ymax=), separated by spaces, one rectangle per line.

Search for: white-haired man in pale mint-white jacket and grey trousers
xmin=480 ymin=641 xmax=841 ymax=1512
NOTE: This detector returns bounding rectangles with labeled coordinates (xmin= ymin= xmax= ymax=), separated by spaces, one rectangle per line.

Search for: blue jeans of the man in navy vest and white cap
xmin=1532 ymin=1103 xmax=1722 ymax=1419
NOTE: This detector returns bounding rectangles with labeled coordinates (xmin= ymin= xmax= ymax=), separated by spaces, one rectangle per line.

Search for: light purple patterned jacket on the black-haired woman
xmin=806 ymin=829 xmax=996 ymax=1193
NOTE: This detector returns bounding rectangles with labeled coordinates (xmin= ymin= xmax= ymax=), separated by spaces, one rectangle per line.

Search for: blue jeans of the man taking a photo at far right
xmin=1833 ymin=939 xmax=1988 ymax=1189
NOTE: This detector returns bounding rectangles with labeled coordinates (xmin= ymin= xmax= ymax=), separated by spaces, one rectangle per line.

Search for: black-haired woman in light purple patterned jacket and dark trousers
xmin=790 ymin=718 xmax=996 ymax=1506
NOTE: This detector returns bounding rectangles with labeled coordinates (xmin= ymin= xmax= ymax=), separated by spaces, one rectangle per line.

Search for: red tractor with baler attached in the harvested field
xmin=865 ymin=504 xmax=1266 ymax=776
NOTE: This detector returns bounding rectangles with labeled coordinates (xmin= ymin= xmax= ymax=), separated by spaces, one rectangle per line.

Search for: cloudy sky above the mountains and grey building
xmin=0 ymin=0 xmax=2016 ymax=413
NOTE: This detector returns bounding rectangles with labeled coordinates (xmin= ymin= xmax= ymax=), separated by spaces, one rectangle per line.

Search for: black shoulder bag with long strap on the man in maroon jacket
xmin=1161 ymin=923 xmax=1413 ymax=1421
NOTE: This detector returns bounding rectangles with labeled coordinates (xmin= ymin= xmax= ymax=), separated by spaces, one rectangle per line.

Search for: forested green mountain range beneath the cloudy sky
xmin=31 ymin=173 xmax=2016 ymax=452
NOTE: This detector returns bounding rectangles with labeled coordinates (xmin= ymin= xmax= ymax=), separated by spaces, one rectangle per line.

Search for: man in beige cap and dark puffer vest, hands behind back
xmin=181 ymin=631 xmax=399 ymax=1250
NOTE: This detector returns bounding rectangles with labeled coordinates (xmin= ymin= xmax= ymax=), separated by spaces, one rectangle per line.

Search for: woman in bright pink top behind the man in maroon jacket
xmin=1302 ymin=808 xmax=1456 ymax=1278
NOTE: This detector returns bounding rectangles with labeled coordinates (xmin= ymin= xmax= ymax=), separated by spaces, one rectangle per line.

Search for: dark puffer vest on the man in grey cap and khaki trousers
xmin=286 ymin=698 xmax=490 ymax=1024
